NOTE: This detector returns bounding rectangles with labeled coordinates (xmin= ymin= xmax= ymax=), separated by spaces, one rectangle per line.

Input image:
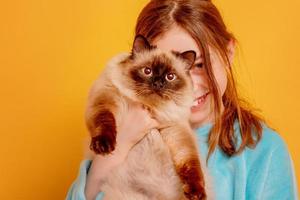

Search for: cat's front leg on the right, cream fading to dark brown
xmin=160 ymin=124 xmax=206 ymax=200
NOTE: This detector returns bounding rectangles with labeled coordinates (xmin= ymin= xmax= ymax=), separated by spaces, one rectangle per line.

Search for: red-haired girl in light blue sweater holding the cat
xmin=67 ymin=0 xmax=297 ymax=200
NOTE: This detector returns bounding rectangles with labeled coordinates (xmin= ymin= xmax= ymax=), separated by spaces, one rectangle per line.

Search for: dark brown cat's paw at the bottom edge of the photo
xmin=183 ymin=182 xmax=206 ymax=200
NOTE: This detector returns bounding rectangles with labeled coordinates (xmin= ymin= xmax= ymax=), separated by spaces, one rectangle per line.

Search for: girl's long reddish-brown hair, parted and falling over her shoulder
xmin=135 ymin=0 xmax=263 ymax=159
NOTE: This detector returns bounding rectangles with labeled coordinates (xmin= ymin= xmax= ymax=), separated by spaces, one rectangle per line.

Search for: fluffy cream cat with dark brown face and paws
xmin=85 ymin=35 xmax=210 ymax=200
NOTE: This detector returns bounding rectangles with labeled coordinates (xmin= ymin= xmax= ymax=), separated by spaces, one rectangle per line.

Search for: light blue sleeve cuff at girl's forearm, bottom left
xmin=66 ymin=160 xmax=104 ymax=200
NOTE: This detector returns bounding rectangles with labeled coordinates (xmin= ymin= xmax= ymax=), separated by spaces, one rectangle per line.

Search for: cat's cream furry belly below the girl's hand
xmin=102 ymin=131 xmax=181 ymax=200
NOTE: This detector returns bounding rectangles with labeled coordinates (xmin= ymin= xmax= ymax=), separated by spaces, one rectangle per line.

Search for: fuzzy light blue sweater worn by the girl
xmin=66 ymin=123 xmax=298 ymax=200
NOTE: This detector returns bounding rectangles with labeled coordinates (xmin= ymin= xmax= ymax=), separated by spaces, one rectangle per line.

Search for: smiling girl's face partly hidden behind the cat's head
xmin=153 ymin=26 xmax=227 ymax=127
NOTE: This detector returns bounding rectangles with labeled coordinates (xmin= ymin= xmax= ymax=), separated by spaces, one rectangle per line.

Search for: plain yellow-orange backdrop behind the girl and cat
xmin=0 ymin=0 xmax=300 ymax=200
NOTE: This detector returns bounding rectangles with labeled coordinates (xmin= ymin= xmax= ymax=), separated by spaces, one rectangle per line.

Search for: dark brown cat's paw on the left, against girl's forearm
xmin=90 ymin=134 xmax=116 ymax=155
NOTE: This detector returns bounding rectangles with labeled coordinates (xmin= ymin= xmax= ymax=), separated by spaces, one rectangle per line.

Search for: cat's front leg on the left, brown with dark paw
xmin=86 ymin=91 xmax=117 ymax=155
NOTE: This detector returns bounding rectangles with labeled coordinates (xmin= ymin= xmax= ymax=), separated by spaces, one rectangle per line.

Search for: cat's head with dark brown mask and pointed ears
xmin=123 ymin=36 xmax=196 ymax=108
